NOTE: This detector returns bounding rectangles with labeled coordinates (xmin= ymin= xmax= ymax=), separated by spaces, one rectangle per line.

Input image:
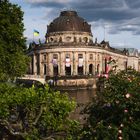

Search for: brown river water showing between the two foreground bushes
xmin=63 ymin=89 xmax=95 ymax=124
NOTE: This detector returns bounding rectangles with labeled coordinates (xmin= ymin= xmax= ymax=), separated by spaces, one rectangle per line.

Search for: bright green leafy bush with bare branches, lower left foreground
xmin=0 ymin=84 xmax=78 ymax=140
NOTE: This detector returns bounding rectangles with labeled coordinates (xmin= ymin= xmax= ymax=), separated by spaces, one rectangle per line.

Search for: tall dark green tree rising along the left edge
xmin=0 ymin=0 xmax=28 ymax=81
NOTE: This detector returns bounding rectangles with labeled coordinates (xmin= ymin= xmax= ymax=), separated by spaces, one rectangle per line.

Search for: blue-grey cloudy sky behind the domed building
xmin=10 ymin=0 xmax=140 ymax=50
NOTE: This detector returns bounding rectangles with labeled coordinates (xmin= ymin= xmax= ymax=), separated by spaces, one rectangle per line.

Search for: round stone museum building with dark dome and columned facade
xmin=28 ymin=11 xmax=140 ymax=87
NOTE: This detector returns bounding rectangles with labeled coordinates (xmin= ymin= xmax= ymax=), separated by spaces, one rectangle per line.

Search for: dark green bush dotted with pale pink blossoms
xmin=82 ymin=69 xmax=140 ymax=140
